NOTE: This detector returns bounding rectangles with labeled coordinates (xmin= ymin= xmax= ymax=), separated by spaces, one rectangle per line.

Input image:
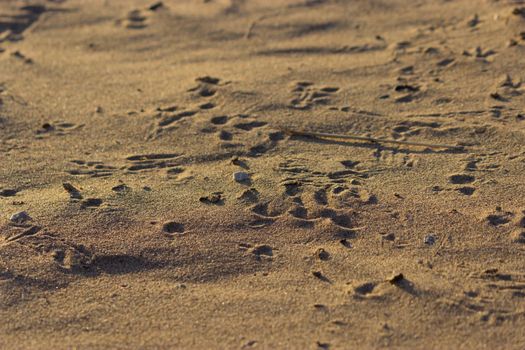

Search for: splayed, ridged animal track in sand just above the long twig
xmin=289 ymin=81 xmax=339 ymax=109
